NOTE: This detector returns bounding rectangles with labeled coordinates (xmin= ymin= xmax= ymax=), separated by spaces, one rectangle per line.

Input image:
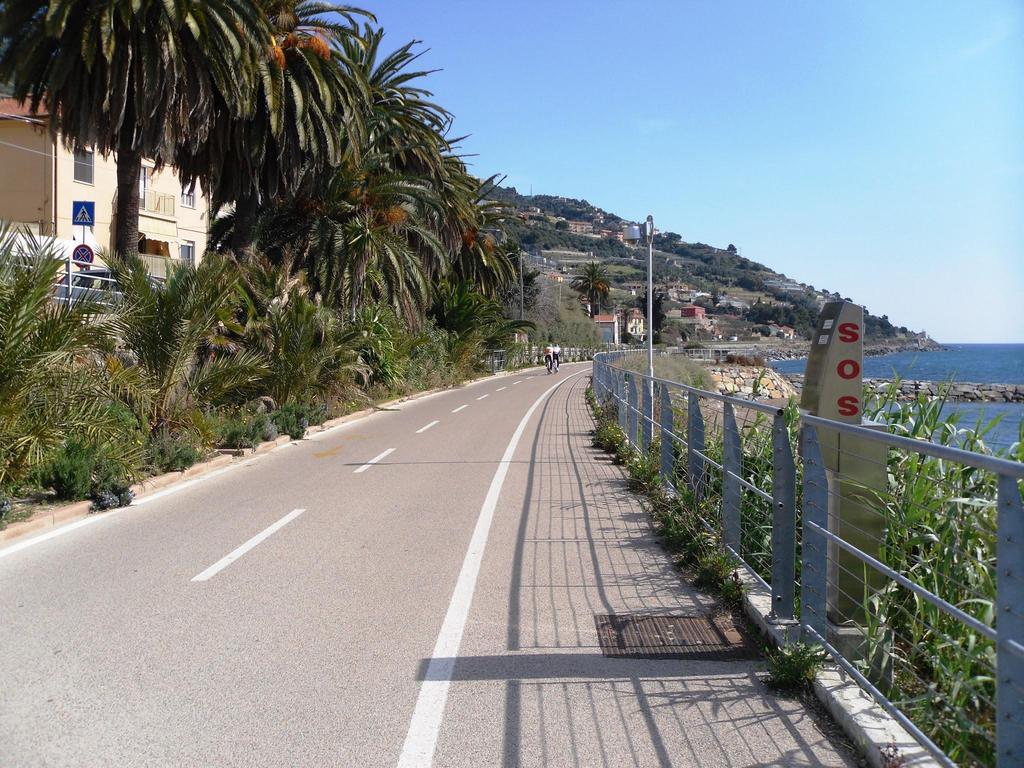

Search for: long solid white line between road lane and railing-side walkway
xmin=398 ymin=371 xmax=584 ymax=768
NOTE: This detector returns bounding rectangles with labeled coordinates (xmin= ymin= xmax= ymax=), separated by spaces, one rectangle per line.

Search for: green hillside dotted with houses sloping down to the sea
xmin=490 ymin=186 xmax=927 ymax=344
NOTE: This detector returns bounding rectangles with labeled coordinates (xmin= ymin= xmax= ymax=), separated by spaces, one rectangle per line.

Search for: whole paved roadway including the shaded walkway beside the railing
xmin=0 ymin=365 xmax=850 ymax=768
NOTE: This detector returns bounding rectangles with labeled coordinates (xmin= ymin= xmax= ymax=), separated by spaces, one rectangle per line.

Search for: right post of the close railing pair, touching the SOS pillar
xmin=800 ymin=425 xmax=828 ymax=639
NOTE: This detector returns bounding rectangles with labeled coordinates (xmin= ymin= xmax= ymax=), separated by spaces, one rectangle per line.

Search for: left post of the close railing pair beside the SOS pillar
xmin=768 ymin=412 xmax=797 ymax=622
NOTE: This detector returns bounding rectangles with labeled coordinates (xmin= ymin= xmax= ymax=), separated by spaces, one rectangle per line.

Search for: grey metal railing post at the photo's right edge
xmin=995 ymin=475 xmax=1024 ymax=767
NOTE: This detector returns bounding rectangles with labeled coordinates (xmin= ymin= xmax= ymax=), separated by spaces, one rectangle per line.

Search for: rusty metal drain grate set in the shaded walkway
xmin=594 ymin=613 xmax=759 ymax=662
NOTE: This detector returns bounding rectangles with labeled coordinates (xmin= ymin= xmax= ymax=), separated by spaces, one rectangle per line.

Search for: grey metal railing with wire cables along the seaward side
xmin=593 ymin=352 xmax=1024 ymax=768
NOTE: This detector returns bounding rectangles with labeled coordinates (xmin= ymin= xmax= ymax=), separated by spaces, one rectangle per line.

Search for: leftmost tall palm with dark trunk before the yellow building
xmin=0 ymin=0 xmax=270 ymax=255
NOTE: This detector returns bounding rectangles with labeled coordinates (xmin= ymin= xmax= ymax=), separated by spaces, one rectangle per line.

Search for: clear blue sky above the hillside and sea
xmin=372 ymin=0 xmax=1024 ymax=343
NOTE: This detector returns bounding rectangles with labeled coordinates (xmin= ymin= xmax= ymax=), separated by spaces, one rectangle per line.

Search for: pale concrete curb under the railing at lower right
xmin=739 ymin=565 xmax=940 ymax=768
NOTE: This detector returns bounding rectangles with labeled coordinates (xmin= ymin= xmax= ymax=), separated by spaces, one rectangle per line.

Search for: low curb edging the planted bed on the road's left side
xmin=0 ymin=367 xmax=548 ymax=544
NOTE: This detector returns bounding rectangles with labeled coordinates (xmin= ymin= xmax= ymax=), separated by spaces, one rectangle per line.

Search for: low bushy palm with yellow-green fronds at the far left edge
xmin=0 ymin=228 xmax=138 ymax=493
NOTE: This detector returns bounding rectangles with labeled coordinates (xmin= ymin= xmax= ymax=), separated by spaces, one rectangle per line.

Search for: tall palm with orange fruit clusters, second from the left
xmin=176 ymin=0 xmax=373 ymax=251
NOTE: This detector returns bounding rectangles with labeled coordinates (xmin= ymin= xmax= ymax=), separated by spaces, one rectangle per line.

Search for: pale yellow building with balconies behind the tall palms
xmin=0 ymin=98 xmax=209 ymax=276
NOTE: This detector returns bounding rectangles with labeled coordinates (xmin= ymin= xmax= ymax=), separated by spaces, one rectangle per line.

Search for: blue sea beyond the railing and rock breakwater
xmin=772 ymin=344 xmax=1024 ymax=449
